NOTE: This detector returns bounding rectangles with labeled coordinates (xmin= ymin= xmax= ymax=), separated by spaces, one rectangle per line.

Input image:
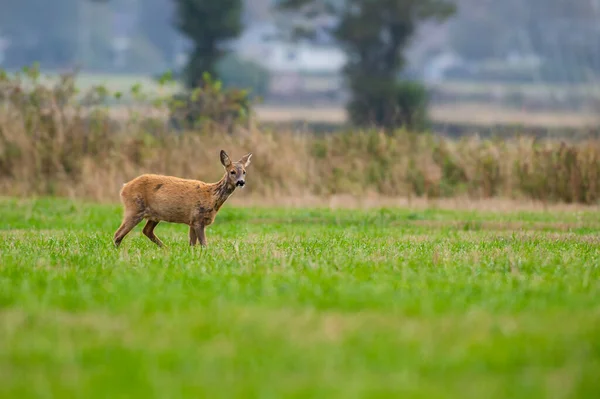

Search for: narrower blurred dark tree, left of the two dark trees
xmin=175 ymin=0 xmax=242 ymax=87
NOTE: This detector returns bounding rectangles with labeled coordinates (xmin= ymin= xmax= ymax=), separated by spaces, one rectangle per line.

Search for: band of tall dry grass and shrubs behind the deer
xmin=0 ymin=67 xmax=600 ymax=204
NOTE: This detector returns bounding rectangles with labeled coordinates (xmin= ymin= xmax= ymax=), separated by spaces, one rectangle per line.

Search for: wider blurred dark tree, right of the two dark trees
xmin=280 ymin=0 xmax=454 ymax=127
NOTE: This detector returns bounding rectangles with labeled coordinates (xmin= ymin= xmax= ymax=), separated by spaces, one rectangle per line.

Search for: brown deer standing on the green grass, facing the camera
xmin=113 ymin=150 xmax=252 ymax=247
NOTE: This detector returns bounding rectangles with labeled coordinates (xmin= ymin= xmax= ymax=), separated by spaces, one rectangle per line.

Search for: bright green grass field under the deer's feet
xmin=0 ymin=199 xmax=600 ymax=399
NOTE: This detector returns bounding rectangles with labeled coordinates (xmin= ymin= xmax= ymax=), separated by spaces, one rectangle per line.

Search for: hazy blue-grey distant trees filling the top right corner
xmin=450 ymin=0 xmax=600 ymax=81
